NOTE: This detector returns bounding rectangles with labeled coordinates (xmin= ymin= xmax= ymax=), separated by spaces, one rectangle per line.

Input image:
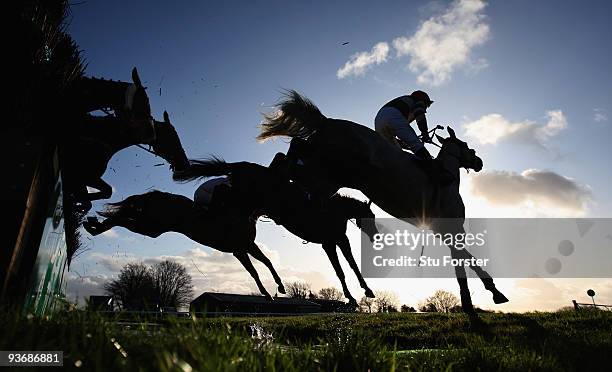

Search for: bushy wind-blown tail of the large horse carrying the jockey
xmin=257 ymin=90 xmax=327 ymax=141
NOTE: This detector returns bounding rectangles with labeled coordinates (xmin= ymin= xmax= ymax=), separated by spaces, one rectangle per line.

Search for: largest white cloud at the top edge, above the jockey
xmin=393 ymin=0 xmax=490 ymax=86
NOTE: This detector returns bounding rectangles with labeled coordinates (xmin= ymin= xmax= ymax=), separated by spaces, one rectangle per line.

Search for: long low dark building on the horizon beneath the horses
xmin=190 ymin=292 xmax=346 ymax=314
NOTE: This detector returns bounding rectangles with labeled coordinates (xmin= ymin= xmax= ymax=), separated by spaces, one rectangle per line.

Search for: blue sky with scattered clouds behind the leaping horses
xmin=63 ymin=0 xmax=612 ymax=311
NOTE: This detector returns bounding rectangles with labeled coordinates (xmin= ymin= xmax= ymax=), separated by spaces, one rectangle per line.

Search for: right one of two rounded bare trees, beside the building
xmin=151 ymin=260 xmax=193 ymax=308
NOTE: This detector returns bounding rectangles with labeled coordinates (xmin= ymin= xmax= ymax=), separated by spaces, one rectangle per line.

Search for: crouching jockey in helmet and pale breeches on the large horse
xmin=374 ymin=90 xmax=433 ymax=159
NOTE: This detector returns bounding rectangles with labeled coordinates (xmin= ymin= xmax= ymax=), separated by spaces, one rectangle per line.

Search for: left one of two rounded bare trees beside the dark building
xmin=104 ymin=263 xmax=157 ymax=310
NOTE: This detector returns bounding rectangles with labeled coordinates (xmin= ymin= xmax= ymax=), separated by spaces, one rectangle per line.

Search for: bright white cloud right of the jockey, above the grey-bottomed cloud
xmin=463 ymin=110 xmax=567 ymax=148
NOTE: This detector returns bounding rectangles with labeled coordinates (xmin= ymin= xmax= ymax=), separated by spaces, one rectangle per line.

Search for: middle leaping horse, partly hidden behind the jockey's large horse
xmin=174 ymin=154 xmax=377 ymax=305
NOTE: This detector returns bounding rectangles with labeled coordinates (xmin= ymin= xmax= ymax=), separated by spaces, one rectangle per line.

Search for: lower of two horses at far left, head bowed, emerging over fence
xmin=61 ymin=112 xmax=189 ymax=212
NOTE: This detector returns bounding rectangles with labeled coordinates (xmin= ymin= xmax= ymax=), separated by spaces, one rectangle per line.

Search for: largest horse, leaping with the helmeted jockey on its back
xmin=258 ymin=91 xmax=508 ymax=315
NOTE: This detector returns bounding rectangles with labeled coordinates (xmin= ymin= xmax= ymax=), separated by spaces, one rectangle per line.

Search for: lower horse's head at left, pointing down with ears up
xmin=152 ymin=111 xmax=189 ymax=171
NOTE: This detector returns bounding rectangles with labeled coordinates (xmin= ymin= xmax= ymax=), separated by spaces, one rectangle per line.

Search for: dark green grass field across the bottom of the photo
xmin=0 ymin=311 xmax=612 ymax=371
